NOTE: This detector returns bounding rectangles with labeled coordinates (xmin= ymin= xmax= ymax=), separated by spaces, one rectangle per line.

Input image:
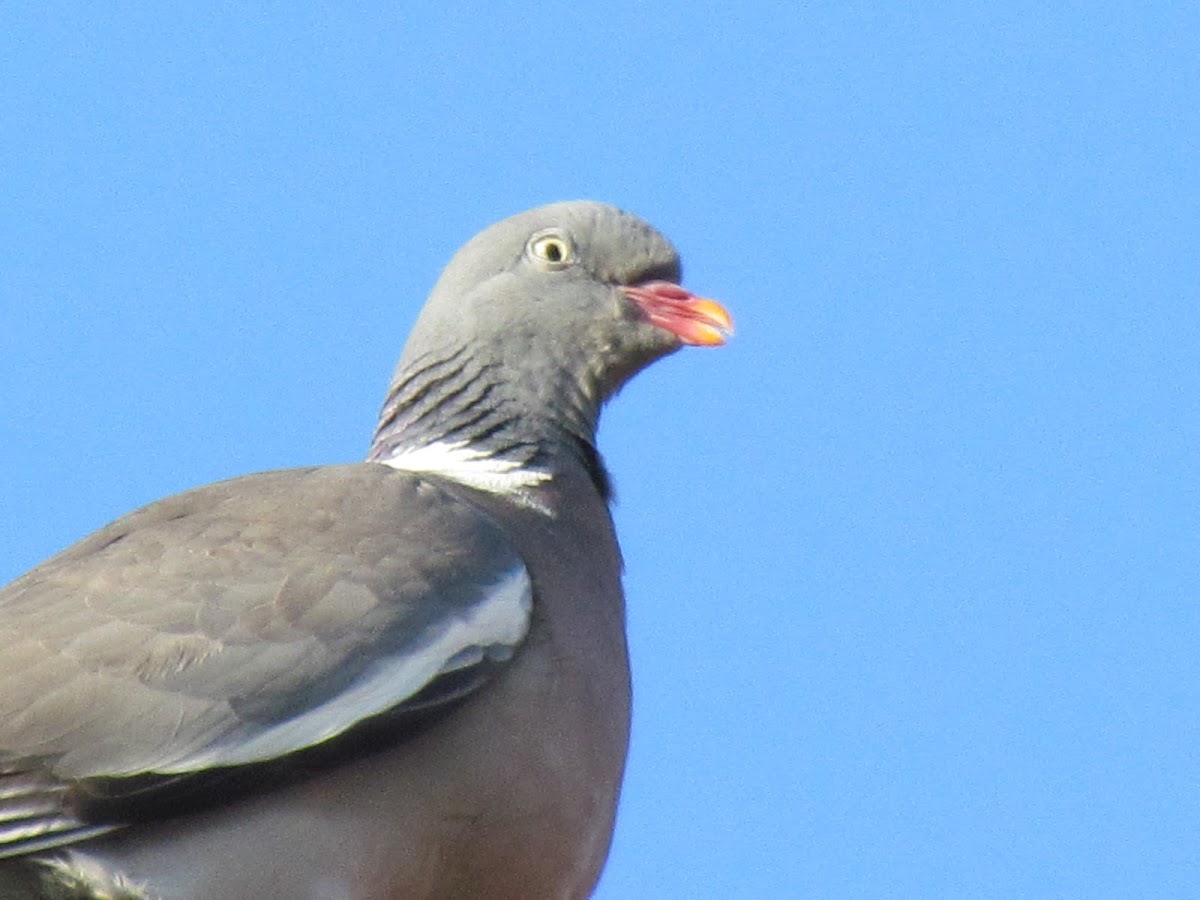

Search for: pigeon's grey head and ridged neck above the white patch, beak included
xmin=368 ymin=200 xmax=732 ymax=501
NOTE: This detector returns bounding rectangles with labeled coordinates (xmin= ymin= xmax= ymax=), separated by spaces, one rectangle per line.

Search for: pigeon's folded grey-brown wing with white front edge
xmin=0 ymin=463 xmax=533 ymax=844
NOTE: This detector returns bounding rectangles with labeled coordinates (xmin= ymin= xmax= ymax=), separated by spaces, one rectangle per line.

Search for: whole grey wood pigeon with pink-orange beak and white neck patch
xmin=0 ymin=202 xmax=732 ymax=900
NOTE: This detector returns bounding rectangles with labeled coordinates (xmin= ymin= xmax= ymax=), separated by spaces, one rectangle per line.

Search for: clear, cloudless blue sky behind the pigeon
xmin=0 ymin=1 xmax=1200 ymax=900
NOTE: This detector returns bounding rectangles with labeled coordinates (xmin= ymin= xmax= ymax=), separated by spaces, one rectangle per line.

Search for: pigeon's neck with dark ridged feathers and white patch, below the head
xmin=367 ymin=348 xmax=610 ymax=512
